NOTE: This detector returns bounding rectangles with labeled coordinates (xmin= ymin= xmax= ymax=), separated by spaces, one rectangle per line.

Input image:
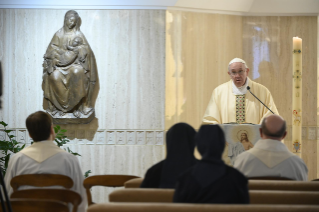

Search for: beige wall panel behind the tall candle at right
xmin=243 ymin=17 xmax=318 ymax=179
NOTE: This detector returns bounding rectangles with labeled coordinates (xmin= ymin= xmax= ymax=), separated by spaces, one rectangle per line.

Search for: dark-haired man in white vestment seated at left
xmin=4 ymin=111 xmax=87 ymax=212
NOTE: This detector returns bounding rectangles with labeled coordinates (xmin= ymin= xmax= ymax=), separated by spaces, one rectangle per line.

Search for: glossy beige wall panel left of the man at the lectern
xmin=165 ymin=10 xmax=242 ymax=129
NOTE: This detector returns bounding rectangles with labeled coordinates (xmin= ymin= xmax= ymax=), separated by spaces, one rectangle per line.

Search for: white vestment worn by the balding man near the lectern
xmin=234 ymin=139 xmax=308 ymax=181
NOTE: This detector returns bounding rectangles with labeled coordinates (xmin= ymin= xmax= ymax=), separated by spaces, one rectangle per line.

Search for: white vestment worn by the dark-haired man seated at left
xmin=4 ymin=141 xmax=87 ymax=212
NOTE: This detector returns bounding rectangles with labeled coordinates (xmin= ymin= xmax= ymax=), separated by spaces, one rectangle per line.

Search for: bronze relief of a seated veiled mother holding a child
xmin=42 ymin=10 xmax=98 ymax=124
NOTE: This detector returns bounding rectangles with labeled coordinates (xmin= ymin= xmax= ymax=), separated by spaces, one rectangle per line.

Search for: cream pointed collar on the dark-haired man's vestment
xmin=20 ymin=140 xmax=65 ymax=163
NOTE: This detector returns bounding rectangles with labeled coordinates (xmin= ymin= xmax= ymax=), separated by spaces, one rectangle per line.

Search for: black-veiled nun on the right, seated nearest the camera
xmin=173 ymin=125 xmax=249 ymax=204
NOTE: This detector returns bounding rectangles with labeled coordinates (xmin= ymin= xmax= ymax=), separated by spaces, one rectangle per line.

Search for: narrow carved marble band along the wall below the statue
xmin=0 ymin=128 xmax=165 ymax=145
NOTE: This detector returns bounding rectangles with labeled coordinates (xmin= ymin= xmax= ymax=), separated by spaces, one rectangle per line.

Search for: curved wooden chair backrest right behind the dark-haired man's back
xmin=10 ymin=174 xmax=73 ymax=192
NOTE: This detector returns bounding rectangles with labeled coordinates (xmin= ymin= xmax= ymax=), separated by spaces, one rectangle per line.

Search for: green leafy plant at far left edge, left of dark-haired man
xmin=0 ymin=121 xmax=25 ymax=176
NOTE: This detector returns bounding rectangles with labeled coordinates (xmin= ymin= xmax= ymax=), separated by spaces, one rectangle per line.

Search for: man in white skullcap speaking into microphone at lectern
xmin=203 ymin=58 xmax=278 ymax=124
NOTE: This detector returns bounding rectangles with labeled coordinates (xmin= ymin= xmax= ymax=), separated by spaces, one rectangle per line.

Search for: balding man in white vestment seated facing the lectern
xmin=234 ymin=115 xmax=308 ymax=181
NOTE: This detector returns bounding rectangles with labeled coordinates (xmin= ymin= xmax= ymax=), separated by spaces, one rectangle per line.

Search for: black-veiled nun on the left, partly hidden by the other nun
xmin=141 ymin=123 xmax=197 ymax=188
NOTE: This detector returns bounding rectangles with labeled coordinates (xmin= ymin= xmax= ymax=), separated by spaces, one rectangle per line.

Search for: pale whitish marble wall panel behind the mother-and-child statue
xmin=0 ymin=9 xmax=166 ymax=130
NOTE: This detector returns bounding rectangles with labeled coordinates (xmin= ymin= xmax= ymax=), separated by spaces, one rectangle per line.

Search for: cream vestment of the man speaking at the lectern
xmin=203 ymin=77 xmax=278 ymax=124
